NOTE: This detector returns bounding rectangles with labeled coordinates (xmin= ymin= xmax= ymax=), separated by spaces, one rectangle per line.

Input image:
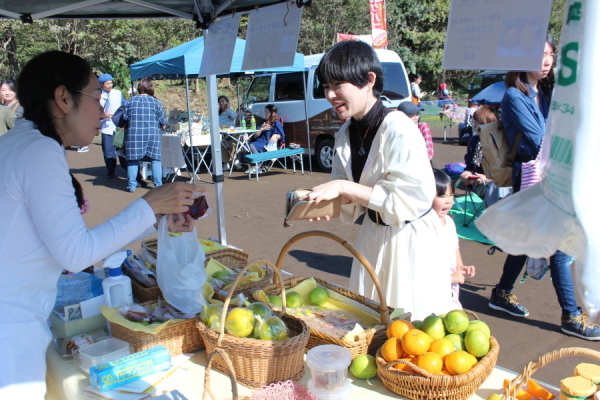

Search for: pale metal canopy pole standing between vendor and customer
xmin=204 ymin=73 xmax=227 ymax=246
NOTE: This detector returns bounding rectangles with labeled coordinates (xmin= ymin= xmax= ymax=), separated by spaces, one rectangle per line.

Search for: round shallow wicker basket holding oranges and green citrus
xmin=376 ymin=310 xmax=500 ymax=400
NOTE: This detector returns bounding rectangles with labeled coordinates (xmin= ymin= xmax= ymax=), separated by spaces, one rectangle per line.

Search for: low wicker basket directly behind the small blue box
xmin=110 ymin=318 xmax=204 ymax=357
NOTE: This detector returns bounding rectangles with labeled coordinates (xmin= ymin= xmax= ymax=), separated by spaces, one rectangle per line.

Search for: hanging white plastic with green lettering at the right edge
xmin=475 ymin=0 xmax=600 ymax=321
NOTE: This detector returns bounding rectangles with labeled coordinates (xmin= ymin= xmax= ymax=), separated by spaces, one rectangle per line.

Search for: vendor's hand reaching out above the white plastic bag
xmin=142 ymin=182 xmax=206 ymax=214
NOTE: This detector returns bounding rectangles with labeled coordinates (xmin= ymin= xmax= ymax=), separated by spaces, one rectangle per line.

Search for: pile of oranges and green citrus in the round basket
xmin=380 ymin=310 xmax=490 ymax=375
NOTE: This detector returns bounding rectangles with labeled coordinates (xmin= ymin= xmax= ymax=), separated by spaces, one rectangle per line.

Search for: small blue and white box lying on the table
xmin=90 ymin=346 xmax=171 ymax=392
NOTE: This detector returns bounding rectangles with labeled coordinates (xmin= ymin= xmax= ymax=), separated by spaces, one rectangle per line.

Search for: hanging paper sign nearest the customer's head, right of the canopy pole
xmin=242 ymin=1 xmax=302 ymax=71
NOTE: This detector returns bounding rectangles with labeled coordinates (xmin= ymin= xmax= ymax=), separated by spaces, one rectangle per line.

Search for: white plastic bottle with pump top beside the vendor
xmin=102 ymin=250 xmax=133 ymax=307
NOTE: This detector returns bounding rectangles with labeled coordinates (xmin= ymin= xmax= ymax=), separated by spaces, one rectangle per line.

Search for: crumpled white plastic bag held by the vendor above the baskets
xmin=156 ymin=216 xmax=207 ymax=318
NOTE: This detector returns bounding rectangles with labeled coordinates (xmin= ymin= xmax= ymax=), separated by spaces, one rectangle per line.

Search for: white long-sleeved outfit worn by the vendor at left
xmin=0 ymin=119 xmax=156 ymax=398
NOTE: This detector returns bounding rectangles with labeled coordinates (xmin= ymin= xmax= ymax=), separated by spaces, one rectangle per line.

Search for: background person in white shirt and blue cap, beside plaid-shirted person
xmin=98 ymin=74 xmax=127 ymax=179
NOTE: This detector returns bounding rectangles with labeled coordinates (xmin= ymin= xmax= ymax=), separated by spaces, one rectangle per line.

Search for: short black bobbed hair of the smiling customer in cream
xmin=316 ymin=40 xmax=383 ymax=97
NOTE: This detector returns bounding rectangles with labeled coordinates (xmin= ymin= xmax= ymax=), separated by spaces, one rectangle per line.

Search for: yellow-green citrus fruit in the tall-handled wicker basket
xmin=200 ymin=302 xmax=289 ymax=340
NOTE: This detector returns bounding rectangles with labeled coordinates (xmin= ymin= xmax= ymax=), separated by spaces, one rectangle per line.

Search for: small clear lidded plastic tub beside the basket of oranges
xmin=306 ymin=344 xmax=351 ymax=392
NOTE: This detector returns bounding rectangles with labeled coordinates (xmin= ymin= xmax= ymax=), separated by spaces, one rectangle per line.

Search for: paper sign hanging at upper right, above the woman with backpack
xmin=442 ymin=0 xmax=552 ymax=71
